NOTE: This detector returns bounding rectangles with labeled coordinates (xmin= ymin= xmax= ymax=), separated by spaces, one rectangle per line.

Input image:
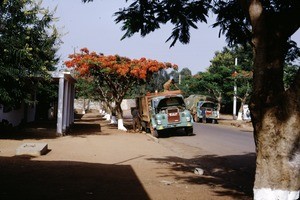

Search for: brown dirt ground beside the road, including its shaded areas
xmin=0 ymin=114 xmax=254 ymax=200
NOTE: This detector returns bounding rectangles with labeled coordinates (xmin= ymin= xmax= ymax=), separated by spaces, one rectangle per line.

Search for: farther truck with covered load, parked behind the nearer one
xmin=185 ymin=95 xmax=219 ymax=123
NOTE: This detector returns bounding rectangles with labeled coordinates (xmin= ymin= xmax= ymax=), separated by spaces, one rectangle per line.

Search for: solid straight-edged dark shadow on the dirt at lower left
xmin=0 ymin=157 xmax=150 ymax=200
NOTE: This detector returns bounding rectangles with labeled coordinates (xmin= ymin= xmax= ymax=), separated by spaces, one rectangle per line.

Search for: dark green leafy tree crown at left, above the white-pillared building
xmin=0 ymin=0 xmax=58 ymax=107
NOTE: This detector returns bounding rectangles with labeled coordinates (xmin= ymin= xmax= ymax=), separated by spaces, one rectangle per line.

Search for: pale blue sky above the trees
xmin=43 ymin=0 xmax=300 ymax=74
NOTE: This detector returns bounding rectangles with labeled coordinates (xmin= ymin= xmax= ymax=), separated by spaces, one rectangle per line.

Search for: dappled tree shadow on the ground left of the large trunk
xmin=149 ymin=153 xmax=256 ymax=200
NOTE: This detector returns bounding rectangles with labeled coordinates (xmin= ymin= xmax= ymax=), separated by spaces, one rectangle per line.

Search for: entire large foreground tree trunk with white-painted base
xmin=250 ymin=1 xmax=300 ymax=200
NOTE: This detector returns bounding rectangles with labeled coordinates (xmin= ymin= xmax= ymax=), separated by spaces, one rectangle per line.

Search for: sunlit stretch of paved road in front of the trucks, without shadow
xmin=161 ymin=123 xmax=255 ymax=156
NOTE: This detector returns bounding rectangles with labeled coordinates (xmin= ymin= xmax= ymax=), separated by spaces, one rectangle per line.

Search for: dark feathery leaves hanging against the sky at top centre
xmin=115 ymin=0 xmax=211 ymax=46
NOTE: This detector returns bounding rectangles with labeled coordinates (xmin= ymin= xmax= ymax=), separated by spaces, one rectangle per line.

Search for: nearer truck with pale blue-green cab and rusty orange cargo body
xmin=136 ymin=90 xmax=194 ymax=137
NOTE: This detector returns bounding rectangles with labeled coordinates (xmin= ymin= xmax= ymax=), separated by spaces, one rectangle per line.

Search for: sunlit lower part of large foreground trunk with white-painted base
xmin=254 ymin=95 xmax=300 ymax=200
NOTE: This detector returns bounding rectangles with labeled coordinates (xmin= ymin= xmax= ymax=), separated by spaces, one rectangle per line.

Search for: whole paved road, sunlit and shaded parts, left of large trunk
xmin=159 ymin=123 xmax=255 ymax=199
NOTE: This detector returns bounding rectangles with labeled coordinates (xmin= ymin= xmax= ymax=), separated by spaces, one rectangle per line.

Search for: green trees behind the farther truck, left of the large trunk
xmin=181 ymin=46 xmax=252 ymax=111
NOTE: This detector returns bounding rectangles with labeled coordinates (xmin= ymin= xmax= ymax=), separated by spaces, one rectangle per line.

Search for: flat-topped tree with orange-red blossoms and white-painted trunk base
xmin=65 ymin=48 xmax=178 ymax=129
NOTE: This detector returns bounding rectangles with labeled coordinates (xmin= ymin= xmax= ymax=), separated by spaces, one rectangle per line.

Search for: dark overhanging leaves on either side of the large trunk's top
xmin=212 ymin=0 xmax=300 ymax=50
